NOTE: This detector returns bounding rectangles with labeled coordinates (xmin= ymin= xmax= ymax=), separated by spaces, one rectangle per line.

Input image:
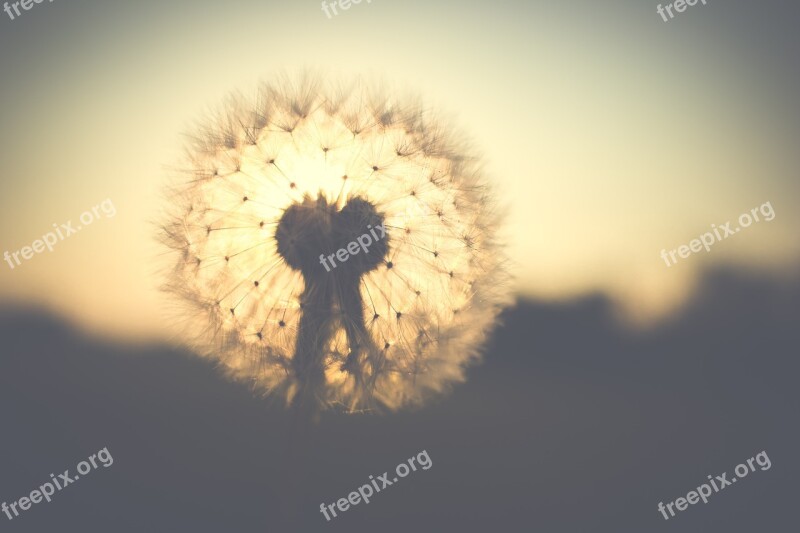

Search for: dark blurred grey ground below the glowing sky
xmin=0 ymin=272 xmax=800 ymax=533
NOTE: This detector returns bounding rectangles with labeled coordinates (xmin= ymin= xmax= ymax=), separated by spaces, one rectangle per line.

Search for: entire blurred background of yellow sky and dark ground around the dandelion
xmin=0 ymin=0 xmax=800 ymax=531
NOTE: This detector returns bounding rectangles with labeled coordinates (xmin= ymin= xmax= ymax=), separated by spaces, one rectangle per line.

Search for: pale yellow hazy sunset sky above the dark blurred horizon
xmin=0 ymin=0 xmax=800 ymax=338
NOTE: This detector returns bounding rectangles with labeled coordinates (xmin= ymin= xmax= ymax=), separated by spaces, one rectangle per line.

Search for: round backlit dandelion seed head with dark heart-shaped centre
xmin=163 ymin=75 xmax=509 ymax=411
